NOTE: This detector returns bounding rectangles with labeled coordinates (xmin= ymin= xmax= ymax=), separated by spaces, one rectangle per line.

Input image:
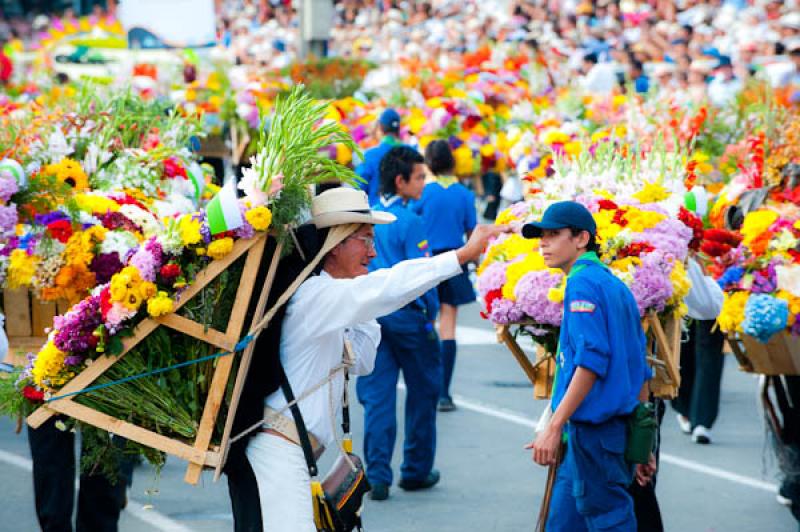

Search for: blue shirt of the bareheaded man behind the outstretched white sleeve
xmin=369 ymin=196 xmax=439 ymax=321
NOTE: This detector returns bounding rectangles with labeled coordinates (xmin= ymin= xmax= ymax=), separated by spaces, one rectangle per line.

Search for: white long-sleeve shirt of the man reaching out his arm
xmin=266 ymin=252 xmax=461 ymax=447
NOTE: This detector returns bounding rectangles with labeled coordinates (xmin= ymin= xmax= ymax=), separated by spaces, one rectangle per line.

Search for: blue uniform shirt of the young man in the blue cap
xmin=552 ymin=253 xmax=652 ymax=423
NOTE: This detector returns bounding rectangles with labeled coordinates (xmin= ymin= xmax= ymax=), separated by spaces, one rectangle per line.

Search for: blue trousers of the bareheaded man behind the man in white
xmin=356 ymin=309 xmax=442 ymax=485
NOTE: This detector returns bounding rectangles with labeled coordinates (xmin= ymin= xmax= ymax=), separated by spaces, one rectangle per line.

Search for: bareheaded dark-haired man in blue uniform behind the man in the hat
xmin=356 ymin=146 xmax=442 ymax=500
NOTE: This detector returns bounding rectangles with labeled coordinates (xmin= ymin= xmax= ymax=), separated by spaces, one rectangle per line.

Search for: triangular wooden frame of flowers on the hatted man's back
xmin=27 ymin=235 xmax=281 ymax=484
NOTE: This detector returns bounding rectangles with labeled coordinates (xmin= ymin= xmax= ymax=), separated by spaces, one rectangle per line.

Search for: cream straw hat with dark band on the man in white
xmin=311 ymin=187 xmax=397 ymax=229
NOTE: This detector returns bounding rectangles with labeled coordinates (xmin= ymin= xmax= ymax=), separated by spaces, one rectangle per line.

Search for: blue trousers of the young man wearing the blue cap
xmin=546 ymin=418 xmax=636 ymax=532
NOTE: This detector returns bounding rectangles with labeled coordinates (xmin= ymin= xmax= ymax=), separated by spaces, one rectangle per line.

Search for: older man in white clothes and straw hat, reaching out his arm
xmin=247 ymin=188 xmax=508 ymax=532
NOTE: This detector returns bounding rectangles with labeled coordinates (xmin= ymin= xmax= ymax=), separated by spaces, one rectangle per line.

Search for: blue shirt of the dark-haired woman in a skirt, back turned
xmin=412 ymin=178 xmax=477 ymax=253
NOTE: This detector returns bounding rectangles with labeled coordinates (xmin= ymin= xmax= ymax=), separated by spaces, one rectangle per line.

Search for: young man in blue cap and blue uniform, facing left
xmin=522 ymin=201 xmax=651 ymax=532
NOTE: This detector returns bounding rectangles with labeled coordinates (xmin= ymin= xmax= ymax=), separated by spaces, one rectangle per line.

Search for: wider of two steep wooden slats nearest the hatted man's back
xmin=184 ymin=235 xmax=267 ymax=484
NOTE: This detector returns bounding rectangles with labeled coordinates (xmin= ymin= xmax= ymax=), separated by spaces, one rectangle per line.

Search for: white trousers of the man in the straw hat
xmin=247 ymin=432 xmax=317 ymax=532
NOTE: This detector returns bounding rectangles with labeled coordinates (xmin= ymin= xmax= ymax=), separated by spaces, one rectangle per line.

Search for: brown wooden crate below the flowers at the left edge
xmin=3 ymin=288 xmax=69 ymax=366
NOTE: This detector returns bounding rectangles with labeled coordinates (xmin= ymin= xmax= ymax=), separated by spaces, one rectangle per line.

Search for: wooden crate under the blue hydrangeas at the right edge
xmin=728 ymin=331 xmax=800 ymax=375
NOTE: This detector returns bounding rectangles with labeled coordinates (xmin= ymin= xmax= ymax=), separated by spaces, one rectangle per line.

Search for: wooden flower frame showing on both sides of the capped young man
xmin=497 ymin=313 xmax=681 ymax=399
